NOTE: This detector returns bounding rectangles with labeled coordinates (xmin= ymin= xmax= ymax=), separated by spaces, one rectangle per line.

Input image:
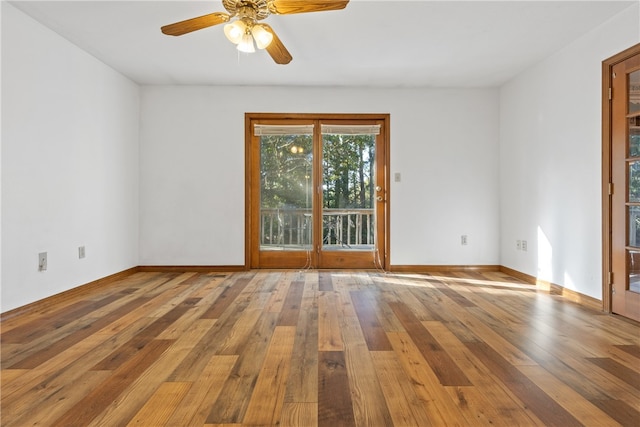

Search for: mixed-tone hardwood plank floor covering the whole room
xmin=1 ymin=271 xmax=640 ymax=427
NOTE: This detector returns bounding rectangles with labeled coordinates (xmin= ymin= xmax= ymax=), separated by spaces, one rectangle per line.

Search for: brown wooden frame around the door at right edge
xmin=602 ymin=43 xmax=640 ymax=313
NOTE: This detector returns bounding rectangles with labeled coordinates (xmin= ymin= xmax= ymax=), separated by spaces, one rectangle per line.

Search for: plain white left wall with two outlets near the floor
xmin=0 ymin=2 xmax=139 ymax=312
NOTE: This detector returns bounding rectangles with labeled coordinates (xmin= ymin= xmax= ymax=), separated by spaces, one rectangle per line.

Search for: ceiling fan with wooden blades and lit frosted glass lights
xmin=161 ymin=0 xmax=349 ymax=64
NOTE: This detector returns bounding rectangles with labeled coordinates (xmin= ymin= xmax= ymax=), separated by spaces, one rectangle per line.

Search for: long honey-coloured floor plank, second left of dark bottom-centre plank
xmin=242 ymin=326 xmax=296 ymax=425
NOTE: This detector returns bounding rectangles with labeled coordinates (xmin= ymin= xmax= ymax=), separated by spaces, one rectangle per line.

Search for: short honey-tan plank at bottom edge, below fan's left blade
xmin=127 ymin=382 xmax=191 ymax=427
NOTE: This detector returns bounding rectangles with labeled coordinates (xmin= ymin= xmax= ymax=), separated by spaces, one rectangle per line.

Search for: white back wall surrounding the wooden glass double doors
xmin=140 ymin=86 xmax=499 ymax=265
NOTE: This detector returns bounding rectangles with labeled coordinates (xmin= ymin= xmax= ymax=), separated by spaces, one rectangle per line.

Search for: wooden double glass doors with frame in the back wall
xmin=246 ymin=114 xmax=389 ymax=268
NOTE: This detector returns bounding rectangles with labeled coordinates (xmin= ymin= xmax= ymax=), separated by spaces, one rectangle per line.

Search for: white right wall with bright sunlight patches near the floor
xmin=500 ymin=4 xmax=640 ymax=299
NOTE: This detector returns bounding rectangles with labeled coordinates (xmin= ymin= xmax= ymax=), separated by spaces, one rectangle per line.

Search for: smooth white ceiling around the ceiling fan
xmin=11 ymin=0 xmax=638 ymax=87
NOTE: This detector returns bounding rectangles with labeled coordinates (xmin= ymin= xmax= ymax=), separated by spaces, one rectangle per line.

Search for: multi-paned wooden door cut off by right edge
xmin=609 ymin=45 xmax=640 ymax=321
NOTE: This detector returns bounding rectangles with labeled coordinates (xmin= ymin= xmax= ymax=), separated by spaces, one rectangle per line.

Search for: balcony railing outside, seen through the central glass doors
xmin=260 ymin=209 xmax=375 ymax=250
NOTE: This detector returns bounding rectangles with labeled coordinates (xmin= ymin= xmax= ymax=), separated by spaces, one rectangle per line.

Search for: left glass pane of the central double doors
xmin=260 ymin=134 xmax=313 ymax=250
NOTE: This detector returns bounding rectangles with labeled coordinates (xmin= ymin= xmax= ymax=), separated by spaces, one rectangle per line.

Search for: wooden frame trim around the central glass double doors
xmin=244 ymin=113 xmax=391 ymax=269
